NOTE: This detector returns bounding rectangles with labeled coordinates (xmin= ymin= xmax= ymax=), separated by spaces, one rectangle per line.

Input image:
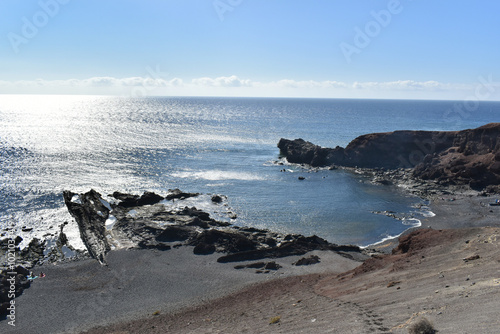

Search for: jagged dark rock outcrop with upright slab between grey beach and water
xmin=64 ymin=189 xmax=361 ymax=264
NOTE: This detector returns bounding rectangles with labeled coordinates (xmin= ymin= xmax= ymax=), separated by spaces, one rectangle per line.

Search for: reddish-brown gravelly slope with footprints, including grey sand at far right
xmin=82 ymin=195 xmax=500 ymax=334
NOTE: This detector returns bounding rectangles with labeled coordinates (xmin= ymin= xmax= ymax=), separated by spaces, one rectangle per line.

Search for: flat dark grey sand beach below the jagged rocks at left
xmin=0 ymin=247 xmax=360 ymax=334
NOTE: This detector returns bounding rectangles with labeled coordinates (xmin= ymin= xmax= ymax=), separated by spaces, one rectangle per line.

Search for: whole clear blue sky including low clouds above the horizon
xmin=0 ymin=0 xmax=500 ymax=100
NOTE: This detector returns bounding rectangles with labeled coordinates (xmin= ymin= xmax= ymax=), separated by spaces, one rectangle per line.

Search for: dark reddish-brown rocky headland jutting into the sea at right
xmin=278 ymin=123 xmax=500 ymax=189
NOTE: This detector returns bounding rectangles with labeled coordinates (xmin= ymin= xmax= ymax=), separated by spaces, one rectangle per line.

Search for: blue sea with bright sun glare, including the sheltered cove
xmin=0 ymin=95 xmax=500 ymax=248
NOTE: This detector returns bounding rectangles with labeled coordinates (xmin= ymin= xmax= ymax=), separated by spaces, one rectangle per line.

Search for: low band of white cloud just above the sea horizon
xmin=0 ymin=75 xmax=500 ymax=100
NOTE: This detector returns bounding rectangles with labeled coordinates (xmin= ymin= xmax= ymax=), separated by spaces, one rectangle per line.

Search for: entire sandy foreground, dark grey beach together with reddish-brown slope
xmin=0 ymin=192 xmax=500 ymax=334
